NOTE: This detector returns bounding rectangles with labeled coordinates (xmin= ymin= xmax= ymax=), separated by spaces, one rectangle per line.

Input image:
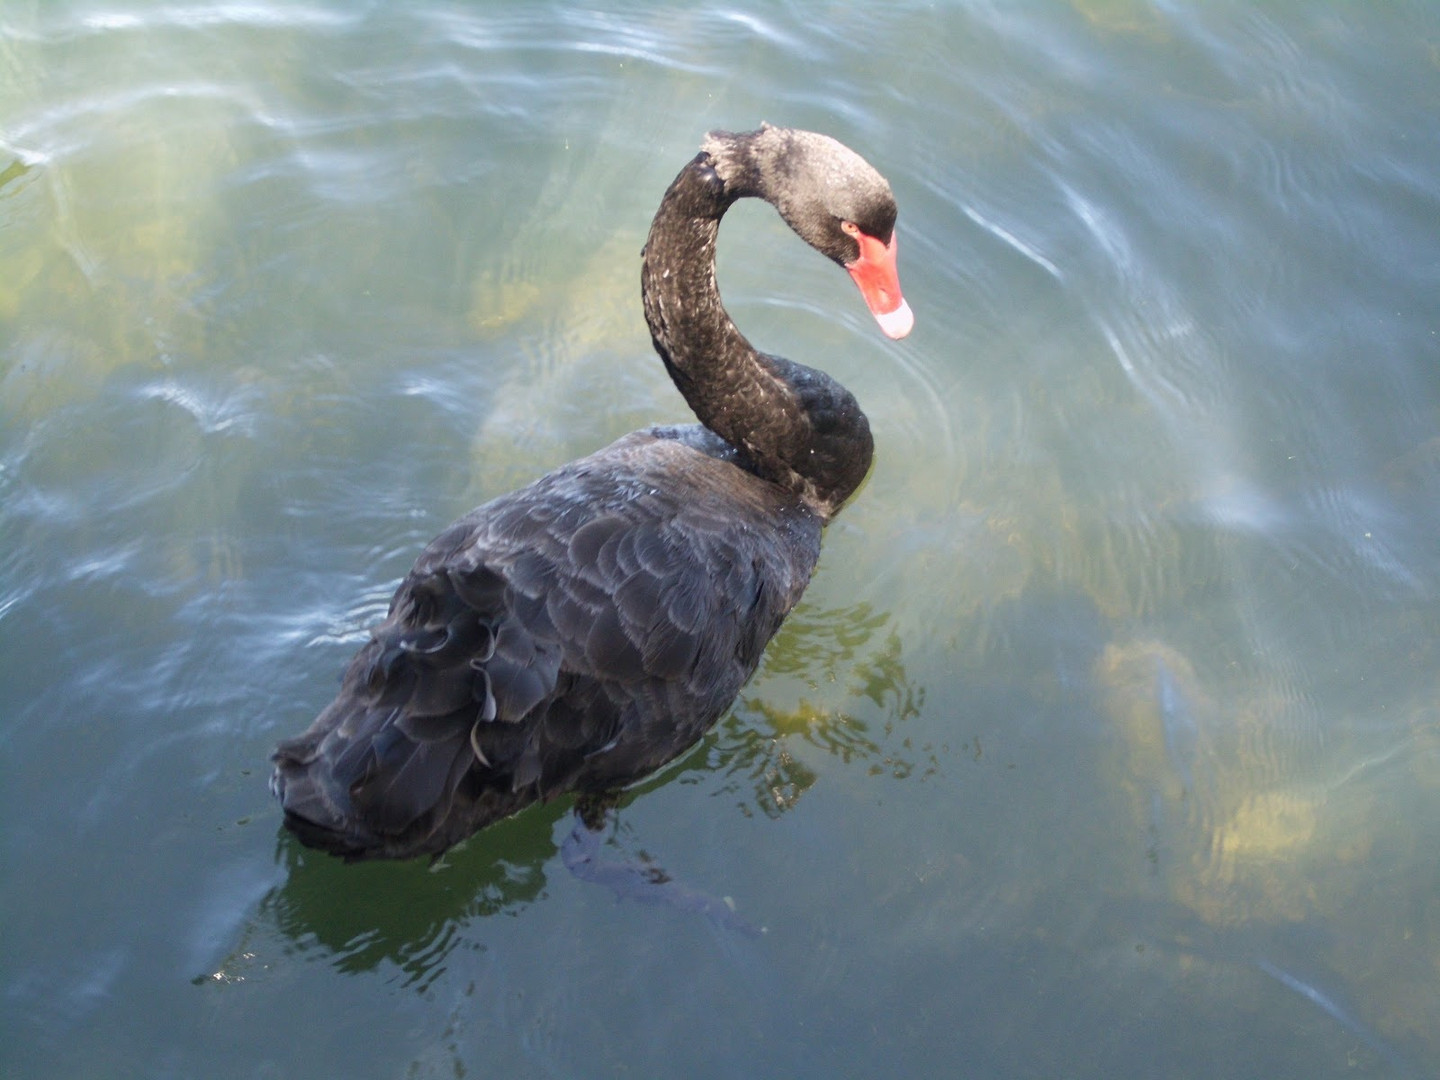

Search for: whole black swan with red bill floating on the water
xmin=271 ymin=125 xmax=914 ymax=858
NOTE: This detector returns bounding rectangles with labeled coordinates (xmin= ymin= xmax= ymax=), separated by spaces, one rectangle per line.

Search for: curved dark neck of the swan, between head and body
xmin=641 ymin=153 xmax=874 ymax=520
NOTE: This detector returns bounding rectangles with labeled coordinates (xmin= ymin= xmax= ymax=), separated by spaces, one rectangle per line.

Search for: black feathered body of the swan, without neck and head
xmin=274 ymin=432 xmax=819 ymax=857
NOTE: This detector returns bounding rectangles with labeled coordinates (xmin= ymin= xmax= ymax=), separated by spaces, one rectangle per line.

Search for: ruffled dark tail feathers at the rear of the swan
xmin=271 ymin=567 xmax=560 ymax=858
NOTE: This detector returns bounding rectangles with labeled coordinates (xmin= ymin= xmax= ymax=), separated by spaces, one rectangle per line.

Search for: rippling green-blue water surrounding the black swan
xmin=0 ymin=0 xmax=1440 ymax=1080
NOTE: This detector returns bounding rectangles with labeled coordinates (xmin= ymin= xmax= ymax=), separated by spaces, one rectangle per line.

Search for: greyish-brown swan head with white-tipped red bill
xmin=703 ymin=124 xmax=914 ymax=338
